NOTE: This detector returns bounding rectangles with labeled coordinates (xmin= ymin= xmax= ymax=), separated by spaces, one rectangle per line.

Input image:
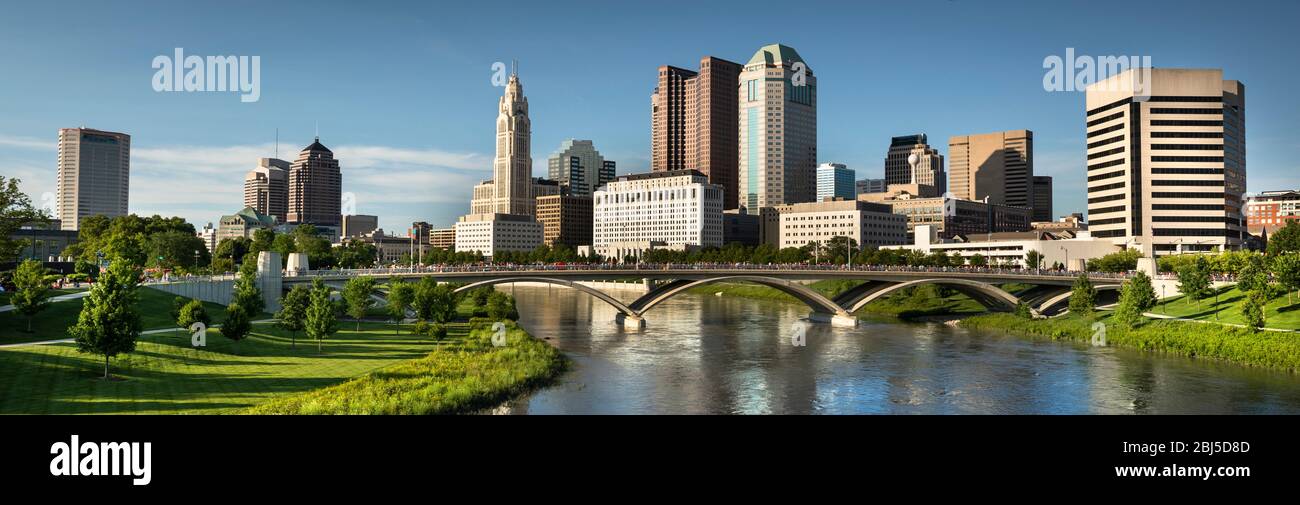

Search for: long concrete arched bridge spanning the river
xmin=274 ymin=266 xmax=1125 ymax=327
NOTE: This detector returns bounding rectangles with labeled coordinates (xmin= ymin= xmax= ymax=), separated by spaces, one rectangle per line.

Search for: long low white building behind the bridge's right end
xmin=881 ymin=224 xmax=1121 ymax=271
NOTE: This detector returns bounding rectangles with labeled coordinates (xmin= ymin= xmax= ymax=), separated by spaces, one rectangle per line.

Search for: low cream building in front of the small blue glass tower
xmin=776 ymin=199 xmax=907 ymax=249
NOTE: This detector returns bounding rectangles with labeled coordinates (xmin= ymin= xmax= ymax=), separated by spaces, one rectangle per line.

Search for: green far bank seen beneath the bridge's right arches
xmin=692 ymin=280 xmax=988 ymax=319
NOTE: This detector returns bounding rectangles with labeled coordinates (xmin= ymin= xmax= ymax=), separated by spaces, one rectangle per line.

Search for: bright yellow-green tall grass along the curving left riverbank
xmin=246 ymin=324 xmax=567 ymax=414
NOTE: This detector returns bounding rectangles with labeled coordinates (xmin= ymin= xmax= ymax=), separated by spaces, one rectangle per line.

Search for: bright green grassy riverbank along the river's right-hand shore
xmin=961 ymin=314 xmax=1300 ymax=372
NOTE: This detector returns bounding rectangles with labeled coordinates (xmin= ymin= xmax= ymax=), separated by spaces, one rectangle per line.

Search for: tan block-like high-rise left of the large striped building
xmin=948 ymin=130 xmax=1034 ymax=209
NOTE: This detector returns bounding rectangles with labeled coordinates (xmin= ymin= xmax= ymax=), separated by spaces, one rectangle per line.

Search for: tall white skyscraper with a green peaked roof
xmin=738 ymin=44 xmax=816 ymax=209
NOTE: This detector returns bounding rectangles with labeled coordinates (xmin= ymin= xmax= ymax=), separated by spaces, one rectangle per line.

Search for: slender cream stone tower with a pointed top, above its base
xmin=493 ymin=72 xmax=534 ymax=215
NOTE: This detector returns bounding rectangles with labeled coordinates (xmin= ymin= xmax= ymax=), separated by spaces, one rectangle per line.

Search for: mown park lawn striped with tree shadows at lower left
xmin=0 ymin=323 xmax=441 ymax=414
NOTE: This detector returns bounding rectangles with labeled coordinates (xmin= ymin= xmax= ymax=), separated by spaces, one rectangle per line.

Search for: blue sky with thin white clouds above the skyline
xmin=0 ymin=0 xmax=1300 ymax=232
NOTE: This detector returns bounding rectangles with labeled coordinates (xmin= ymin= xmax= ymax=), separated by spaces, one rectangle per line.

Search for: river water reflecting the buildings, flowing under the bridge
xmin=497 ymin=286 xmax=1300 ymax=414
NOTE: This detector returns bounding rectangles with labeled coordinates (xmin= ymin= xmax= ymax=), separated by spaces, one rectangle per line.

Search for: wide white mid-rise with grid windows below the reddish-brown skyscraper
xmin=595 ymin=171 xmax=723 ymax=258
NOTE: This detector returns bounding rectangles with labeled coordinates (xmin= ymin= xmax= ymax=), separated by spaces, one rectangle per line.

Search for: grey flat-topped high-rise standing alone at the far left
xmin=56 ymin=128 xmax=131 ymax=230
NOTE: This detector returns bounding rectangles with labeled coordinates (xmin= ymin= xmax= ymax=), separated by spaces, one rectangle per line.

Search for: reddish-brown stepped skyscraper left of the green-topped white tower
xmin=650 ymin=56 xmax=741 ymax=208
